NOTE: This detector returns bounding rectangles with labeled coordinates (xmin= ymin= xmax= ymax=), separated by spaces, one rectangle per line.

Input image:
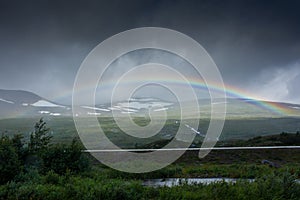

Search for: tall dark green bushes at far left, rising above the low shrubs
xmin=0 ymin=119 xmax=89 ymax=184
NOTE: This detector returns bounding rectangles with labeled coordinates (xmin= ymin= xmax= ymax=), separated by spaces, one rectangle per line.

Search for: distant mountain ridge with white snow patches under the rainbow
xmin=0 ymin=89 xmax=300 ymax=119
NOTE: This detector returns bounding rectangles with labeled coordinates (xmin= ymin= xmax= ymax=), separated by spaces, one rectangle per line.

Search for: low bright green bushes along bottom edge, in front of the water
xmin=0 ymin=172 xmax=300 ymax=200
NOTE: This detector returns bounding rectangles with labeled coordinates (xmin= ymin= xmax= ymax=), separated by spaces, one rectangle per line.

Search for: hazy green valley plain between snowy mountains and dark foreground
xmin=0 ymin=117 xmax=300 ymax=145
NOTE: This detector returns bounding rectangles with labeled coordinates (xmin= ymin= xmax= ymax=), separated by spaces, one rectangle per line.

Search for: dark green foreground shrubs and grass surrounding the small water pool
xmin=0 ymin=120 xmax=300 ymax=199
